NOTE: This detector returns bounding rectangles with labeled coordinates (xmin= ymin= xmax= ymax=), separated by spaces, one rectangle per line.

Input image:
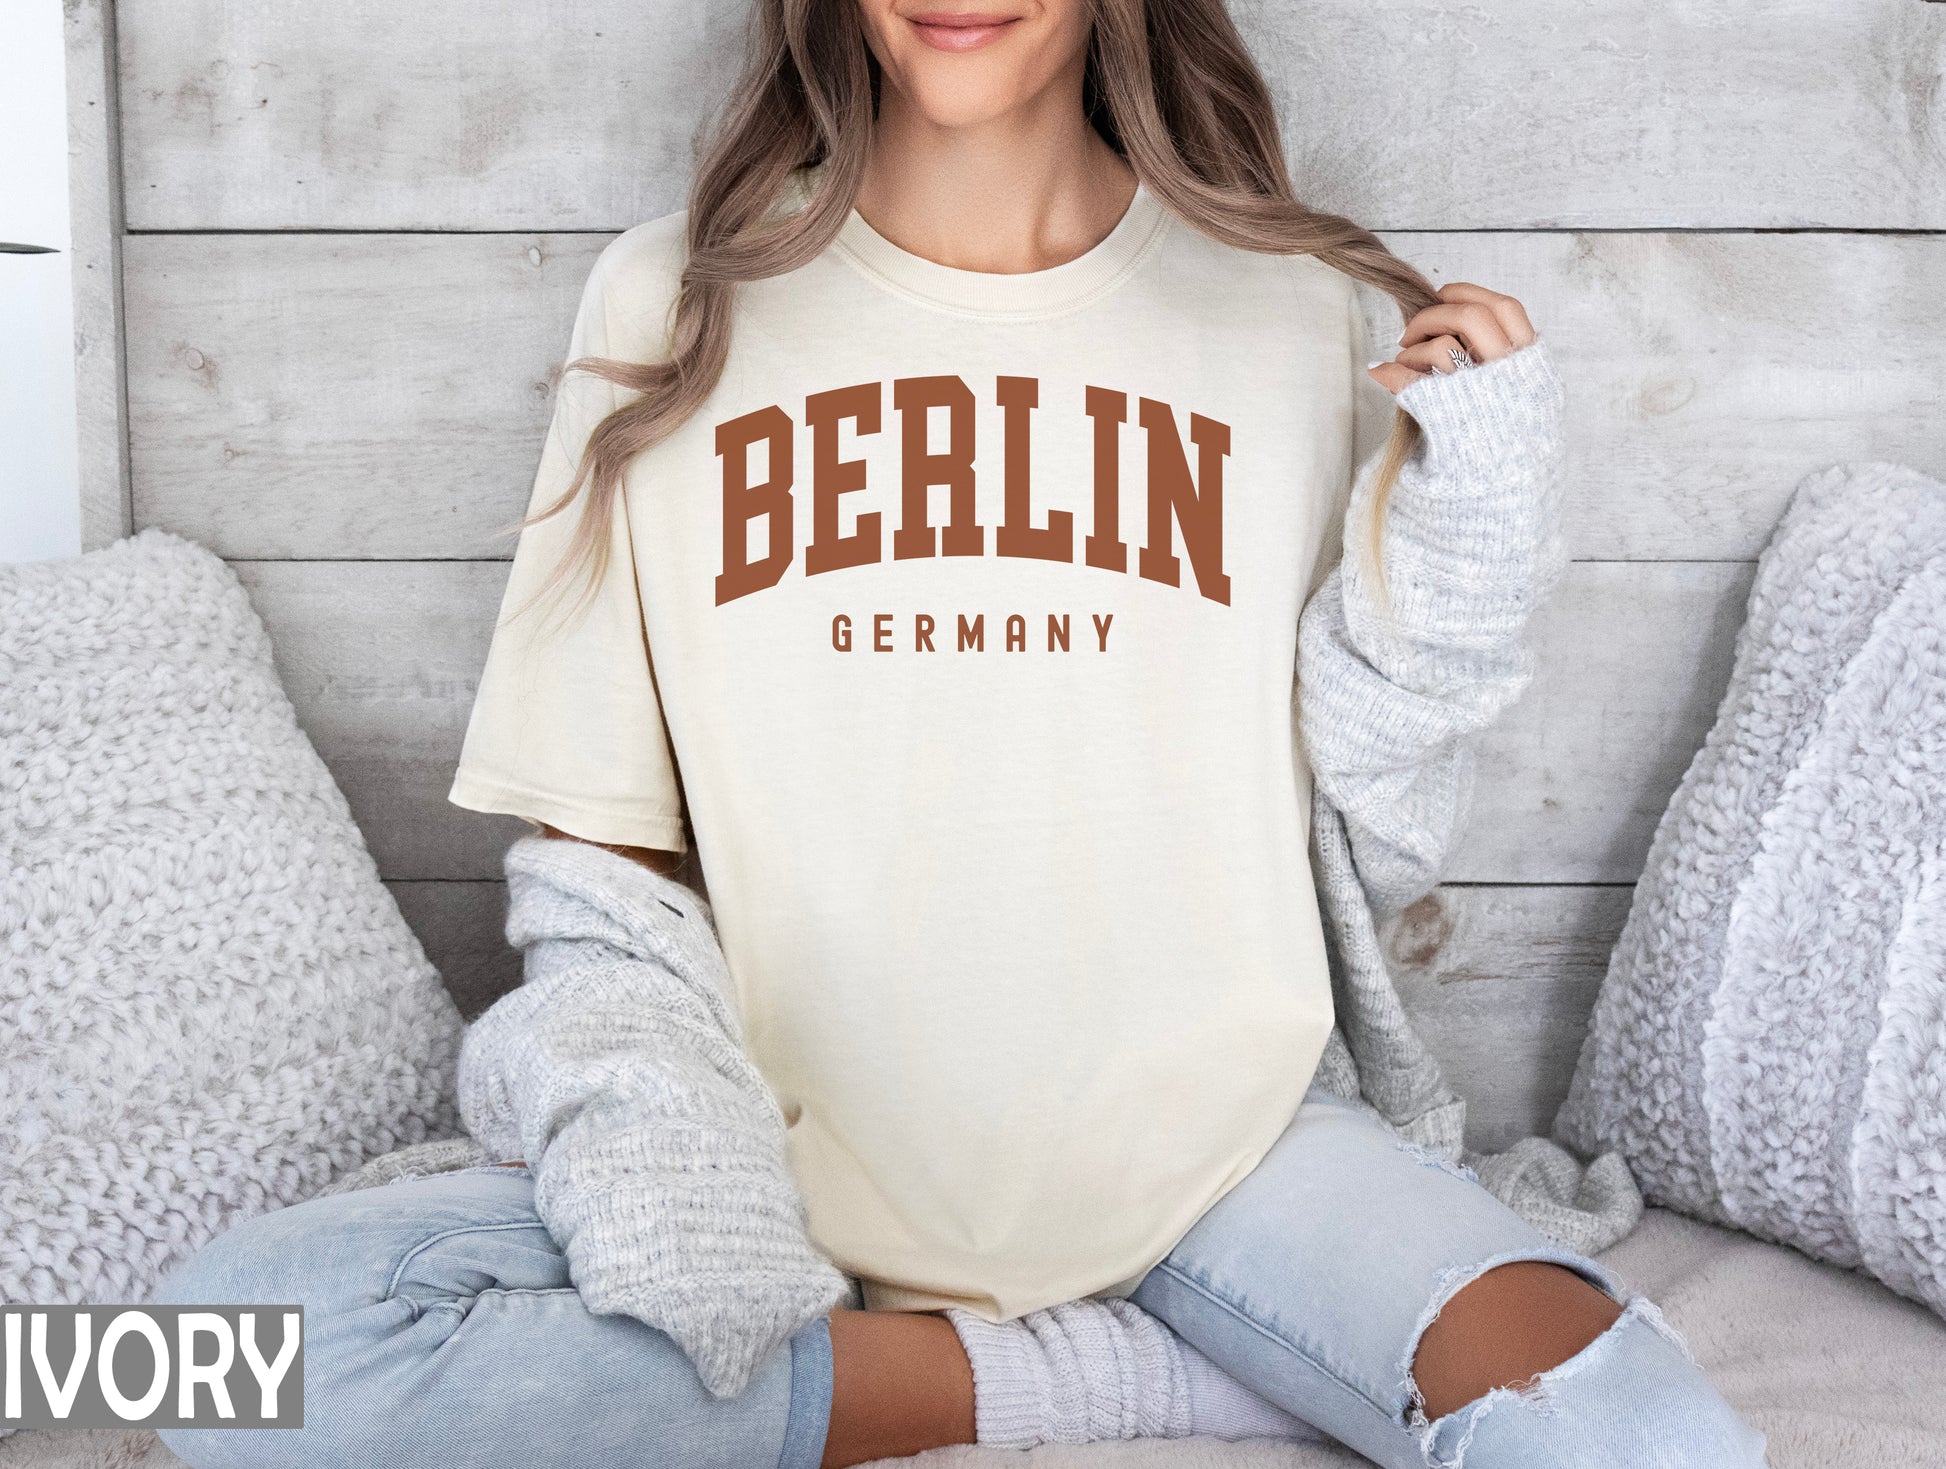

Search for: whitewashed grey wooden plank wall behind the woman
xmin=102 ymin=0 xmax=1946 ymax=1146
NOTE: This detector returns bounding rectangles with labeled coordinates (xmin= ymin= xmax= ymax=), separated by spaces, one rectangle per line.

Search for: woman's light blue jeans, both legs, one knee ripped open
xmin=156 ymin=1088 xmax=1763 ymax=1469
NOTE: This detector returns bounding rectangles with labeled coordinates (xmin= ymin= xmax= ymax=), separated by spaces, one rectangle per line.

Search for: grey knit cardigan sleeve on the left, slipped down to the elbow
xmin=459 ymin=837 xmax=848 ymax=1397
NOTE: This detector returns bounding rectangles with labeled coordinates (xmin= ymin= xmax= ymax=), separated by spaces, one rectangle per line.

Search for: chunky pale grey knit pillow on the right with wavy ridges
xmin=1555 ymin=463 xmax=1946 ymax=1315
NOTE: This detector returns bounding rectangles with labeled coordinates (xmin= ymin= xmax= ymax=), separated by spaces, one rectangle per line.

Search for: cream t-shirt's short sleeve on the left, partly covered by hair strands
xmin=448 ymin=249 xmax=687 ymax=852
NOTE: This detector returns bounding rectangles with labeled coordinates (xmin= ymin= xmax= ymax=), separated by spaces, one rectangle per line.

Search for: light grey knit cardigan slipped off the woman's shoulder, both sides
xmin=448 ymin=332 xmax=1640 ymax=1393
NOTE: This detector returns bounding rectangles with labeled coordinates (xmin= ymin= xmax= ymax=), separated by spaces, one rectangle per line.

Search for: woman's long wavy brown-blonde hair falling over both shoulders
xmin=506 ymin=0 xmax=1436 ymax=626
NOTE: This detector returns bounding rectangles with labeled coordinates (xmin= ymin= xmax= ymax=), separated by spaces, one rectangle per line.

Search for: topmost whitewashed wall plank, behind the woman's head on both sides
xmin=119 ymin=0 xmax=1946 ymax=230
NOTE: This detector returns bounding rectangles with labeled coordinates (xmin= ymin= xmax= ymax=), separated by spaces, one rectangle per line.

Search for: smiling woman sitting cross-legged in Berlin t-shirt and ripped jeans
xmin=165 ymin=0 xmax=1761 ymax=1469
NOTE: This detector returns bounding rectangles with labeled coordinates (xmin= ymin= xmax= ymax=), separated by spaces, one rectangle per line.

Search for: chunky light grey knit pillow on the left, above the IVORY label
xmin=0 ymin=529 xmax=461 ymax=1304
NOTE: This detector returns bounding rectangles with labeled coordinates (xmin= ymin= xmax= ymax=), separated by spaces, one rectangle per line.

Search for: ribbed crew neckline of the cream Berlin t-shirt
xmin=798 ymin=169 xmax=1170 ymax=319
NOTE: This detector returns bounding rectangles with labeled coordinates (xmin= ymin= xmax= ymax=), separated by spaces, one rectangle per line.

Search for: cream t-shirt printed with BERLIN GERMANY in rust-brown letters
xmin=450 ymin=166 xmax=1389 ymax=1319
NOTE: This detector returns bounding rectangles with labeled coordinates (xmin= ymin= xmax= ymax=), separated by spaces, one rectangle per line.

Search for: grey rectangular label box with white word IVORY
xmin=0 ymin=1306 xmax=304 ymax=1428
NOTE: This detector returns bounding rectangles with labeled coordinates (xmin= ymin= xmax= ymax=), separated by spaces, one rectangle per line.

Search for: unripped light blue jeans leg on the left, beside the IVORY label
xmin=156 ymin=1167 xmax=831 ymax=1469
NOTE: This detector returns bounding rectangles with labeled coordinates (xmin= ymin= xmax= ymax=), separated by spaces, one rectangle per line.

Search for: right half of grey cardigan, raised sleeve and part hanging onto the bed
xmin=1298 ymin=339 xmax=1642 ymax=1253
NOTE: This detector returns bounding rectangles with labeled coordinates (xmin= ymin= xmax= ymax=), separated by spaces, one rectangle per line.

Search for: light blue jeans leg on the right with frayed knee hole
xmin=1135 ymin=1088 xmax=1763 ymax=1469
